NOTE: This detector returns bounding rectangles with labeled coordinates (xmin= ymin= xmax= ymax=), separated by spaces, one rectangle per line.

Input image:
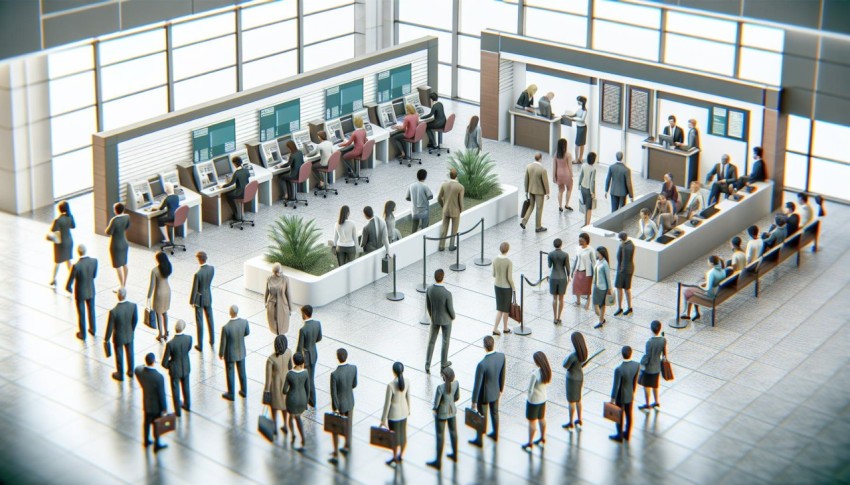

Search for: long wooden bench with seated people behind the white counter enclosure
xmin=676 ymin=219 xmax=820 ymax=327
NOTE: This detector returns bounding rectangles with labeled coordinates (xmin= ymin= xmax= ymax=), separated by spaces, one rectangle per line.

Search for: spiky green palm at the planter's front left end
xmin=266 ymin=216 xmax=327 ymax=271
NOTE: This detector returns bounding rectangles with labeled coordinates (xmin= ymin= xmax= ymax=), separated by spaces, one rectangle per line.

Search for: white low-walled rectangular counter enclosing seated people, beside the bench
xmin=582 ymin=182 xmax=773 ymax=281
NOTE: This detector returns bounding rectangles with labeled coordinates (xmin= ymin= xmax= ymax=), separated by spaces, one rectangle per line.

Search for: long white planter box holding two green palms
xmin=244 ymin=184 xmax=519 ymax=306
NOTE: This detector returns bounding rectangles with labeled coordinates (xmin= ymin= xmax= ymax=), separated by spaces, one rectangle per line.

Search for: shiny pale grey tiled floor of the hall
xmin=6 ymin=100 xmax=850 ymax=484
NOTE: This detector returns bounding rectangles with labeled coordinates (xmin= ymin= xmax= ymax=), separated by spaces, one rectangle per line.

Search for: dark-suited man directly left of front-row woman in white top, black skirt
xmin=469 ymin=335 xmax=505 ymax=447
